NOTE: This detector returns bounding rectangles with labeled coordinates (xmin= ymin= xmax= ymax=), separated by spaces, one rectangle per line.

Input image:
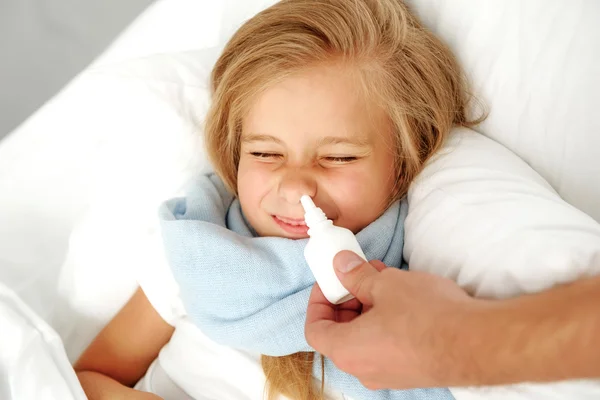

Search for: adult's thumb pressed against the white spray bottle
xmin=333 ymin=250 xmax=379 ymax=305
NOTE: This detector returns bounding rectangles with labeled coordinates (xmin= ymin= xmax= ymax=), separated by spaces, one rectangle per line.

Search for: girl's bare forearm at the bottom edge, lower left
xmin=77 ymin=371 xmax=160 ymax=400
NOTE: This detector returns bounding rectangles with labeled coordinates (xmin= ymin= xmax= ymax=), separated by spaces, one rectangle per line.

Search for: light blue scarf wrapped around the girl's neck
xmin=160 ymin=174 xmax=453 ymax=400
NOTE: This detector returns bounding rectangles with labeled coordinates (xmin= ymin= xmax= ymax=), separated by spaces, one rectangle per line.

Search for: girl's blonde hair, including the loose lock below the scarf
xmin=205 ymin=0 xmax=483 ymax=400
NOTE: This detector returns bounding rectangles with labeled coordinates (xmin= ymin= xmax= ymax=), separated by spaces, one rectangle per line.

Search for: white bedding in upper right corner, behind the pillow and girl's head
xmin=409 ymin=0 xmax=600 ymax=221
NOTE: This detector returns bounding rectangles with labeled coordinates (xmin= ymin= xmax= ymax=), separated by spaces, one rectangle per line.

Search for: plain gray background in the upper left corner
xmin=0 ymin=0 xmax=152 ymax=140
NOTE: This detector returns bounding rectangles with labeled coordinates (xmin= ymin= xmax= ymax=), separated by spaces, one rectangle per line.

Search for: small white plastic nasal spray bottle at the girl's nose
xmin=300 ymin=195 xmax=367 ymax=304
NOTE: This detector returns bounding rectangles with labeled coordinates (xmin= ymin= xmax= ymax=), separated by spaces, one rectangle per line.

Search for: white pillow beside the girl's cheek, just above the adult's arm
xmin=404 ymin=129 xmax=600 ymax=298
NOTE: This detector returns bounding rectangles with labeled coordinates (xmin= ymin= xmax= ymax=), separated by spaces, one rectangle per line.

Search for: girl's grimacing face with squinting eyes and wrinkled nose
xmin=238 ymin=67 xmax=396 ymax=239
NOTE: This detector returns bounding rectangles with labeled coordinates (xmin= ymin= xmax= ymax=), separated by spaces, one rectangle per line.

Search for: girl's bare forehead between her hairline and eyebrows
xmin=243 ymin=66 xmax=387 ymax=139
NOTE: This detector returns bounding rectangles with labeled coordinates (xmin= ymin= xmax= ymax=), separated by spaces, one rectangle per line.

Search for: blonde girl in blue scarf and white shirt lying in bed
xmin=75 ymin=0 xmax=474 ymax=400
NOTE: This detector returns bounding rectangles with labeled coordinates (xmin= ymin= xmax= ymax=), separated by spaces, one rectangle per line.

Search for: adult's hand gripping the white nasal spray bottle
xmin=305 ymin=251 xmax=483 ymax=389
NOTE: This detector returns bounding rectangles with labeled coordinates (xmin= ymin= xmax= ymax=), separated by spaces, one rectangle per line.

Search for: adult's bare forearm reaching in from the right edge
xmin=453 ymin=277 xmax=600 ymax=385
